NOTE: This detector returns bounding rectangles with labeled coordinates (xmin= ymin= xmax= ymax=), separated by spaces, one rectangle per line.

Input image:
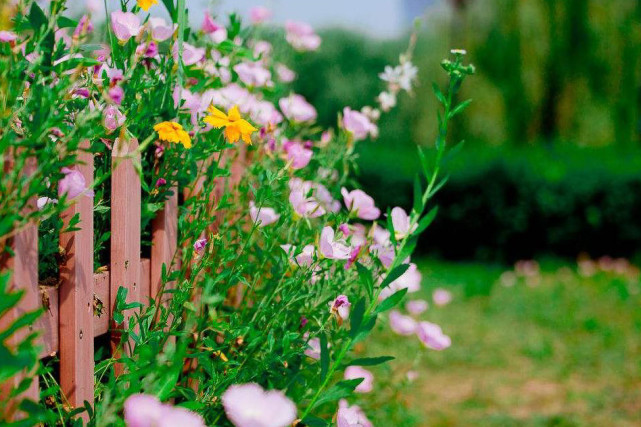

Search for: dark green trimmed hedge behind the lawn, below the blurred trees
xmin=360 ymin=142 xmax=641 ymax=261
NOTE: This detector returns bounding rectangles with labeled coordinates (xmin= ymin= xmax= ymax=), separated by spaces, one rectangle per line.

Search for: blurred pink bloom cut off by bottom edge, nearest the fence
xmin=124 ymin=394 xmax=205 ymax=427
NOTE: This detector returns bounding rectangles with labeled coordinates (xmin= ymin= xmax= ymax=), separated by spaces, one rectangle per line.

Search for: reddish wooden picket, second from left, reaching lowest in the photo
xmin=59 ymin=145 xmax=95 ymax=407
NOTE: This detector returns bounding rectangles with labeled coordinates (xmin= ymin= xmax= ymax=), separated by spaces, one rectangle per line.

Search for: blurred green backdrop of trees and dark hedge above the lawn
xmin=294 ymin=0 xmax=641 ymax=261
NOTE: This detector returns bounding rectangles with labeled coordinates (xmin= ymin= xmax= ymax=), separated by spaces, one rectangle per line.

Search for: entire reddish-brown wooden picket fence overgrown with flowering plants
xmin=0 ymin=135 xmax=230 ymax=417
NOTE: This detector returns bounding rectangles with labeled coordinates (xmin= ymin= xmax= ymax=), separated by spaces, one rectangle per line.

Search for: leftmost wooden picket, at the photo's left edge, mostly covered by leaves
xmin=0 ymin=158 xmax=40 ymax=419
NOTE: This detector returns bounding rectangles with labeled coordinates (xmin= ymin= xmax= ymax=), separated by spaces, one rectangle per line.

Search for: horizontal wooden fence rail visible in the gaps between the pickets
xmin=36 ymin=258 xmax=150 ymax=357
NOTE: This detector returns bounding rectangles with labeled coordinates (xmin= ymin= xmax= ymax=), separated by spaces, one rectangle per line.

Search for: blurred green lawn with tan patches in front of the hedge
xmin=360 ymin=260 xmax=641 ymax=426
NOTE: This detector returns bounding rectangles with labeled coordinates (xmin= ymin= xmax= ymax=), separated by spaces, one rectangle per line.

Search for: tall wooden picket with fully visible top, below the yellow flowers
xmin=109 ymin=138 xmax=142 ymax=375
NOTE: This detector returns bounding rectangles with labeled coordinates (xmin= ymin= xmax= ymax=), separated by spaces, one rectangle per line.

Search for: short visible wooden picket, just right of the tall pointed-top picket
xmin=149 ymin=187 xmax=178 ymax=298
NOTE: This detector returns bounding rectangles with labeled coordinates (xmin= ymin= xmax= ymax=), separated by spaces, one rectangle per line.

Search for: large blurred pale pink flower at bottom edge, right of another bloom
xmin=222 ymin=383 xmax=296 ymax=427
